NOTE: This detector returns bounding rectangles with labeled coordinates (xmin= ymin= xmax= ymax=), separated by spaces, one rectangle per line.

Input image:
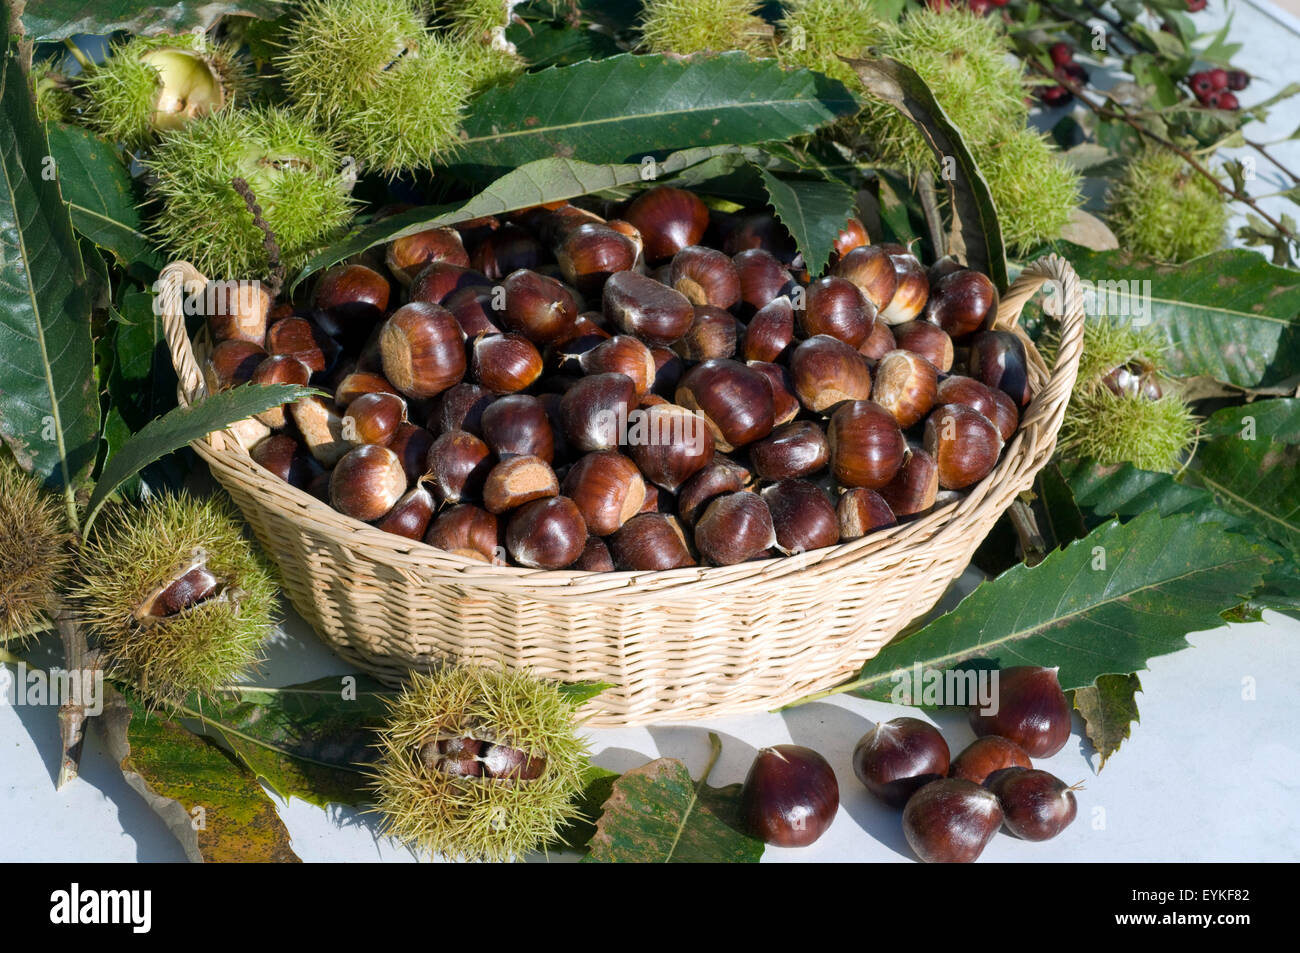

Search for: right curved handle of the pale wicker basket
xmin=993 ymin=255 xmax=1087 ymax=425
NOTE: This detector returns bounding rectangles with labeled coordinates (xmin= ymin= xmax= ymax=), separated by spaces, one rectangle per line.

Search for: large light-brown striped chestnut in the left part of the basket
xmin=380 ymin=302 xmax=465 ymax=398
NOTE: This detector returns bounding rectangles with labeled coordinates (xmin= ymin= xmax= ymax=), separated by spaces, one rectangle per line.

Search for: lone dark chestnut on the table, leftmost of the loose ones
xmin=740 ymin=745 xmax=840 ymax=848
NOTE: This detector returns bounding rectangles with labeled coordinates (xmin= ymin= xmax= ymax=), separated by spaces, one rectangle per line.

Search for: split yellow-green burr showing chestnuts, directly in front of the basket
xmin=372 ymin=666 xmax=586 ymax=861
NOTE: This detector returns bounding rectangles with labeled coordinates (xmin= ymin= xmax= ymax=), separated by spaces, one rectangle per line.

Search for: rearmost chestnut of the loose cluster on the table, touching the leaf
xmin=970 ymin=666 xmax=1070 ymax=758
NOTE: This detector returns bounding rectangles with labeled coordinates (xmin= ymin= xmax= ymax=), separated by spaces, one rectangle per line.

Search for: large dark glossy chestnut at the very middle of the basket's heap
xmin=676 ymin=358 xmax=774 ymax=452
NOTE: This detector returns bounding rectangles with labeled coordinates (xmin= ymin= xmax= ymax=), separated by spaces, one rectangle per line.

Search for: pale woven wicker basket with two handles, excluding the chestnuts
xmin=163 ymin=256 xmax=1084 ymax=725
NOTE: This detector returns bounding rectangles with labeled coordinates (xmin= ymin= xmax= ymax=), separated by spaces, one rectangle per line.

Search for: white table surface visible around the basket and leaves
xmin=0 ymin=0 xmax=1300 ymax=862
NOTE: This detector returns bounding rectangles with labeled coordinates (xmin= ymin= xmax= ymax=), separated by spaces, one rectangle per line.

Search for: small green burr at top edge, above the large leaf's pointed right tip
xmin=777 ymin=0 xmax=885 ymax=86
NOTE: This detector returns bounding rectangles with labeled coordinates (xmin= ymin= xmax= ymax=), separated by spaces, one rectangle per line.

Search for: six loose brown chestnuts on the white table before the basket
xmin=740 ymin=666 xmax=1079 ymax=863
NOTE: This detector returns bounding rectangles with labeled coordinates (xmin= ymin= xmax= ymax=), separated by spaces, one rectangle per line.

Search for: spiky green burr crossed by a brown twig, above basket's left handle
xmin=146 ymin=109 xmax=352 ymax=278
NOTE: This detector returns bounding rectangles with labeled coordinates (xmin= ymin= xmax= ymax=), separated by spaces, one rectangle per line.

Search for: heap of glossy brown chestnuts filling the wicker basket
xmin=205 ymin=186 xmax=1031 ymax=571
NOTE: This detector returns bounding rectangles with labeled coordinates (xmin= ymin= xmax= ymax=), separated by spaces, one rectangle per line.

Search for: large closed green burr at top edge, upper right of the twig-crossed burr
xmin=276 ymin=0 xmax=472 ymax=177
